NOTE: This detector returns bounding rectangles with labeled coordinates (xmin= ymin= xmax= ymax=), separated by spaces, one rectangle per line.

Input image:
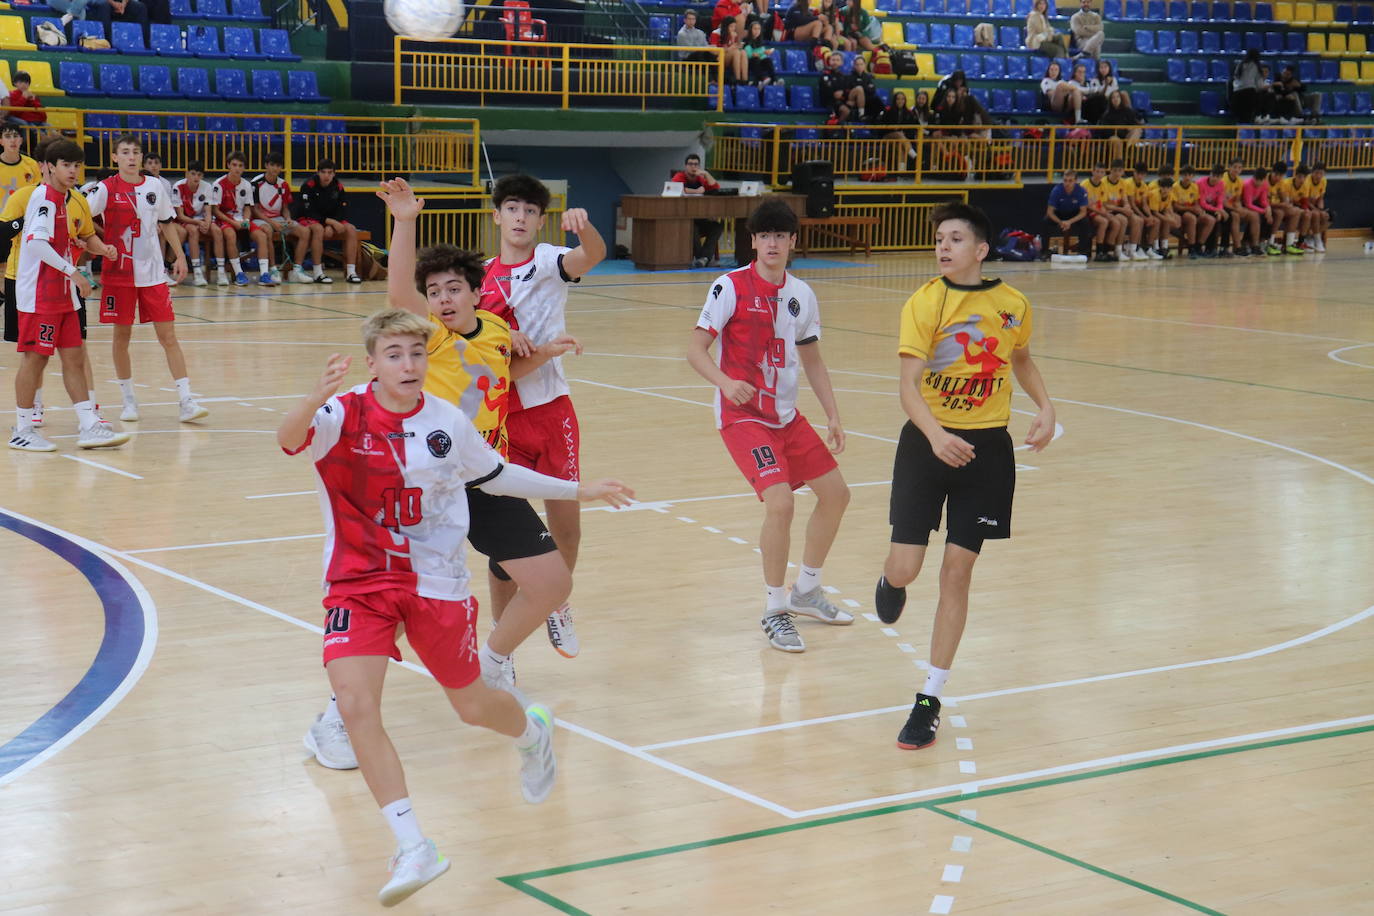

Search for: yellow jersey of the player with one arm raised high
xmin=425 ymin=309 xmax=511 ymax=457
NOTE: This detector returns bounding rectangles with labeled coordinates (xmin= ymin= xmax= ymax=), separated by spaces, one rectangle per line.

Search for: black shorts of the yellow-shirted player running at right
xmin=888 ymin=422 xmax=1017 ymax=553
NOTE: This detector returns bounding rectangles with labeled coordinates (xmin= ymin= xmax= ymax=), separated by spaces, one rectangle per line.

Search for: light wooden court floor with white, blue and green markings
xmin=0 ymin=242 xmax=1374 ymax=916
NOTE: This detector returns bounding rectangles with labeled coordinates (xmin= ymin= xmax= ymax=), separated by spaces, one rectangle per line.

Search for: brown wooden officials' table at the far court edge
xmin=620 ymin=194 xmax=807 ymax=271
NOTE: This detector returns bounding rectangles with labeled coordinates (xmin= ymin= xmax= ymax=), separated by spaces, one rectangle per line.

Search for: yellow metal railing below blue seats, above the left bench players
xmin=63 ymin=108 xmax=481 ymax=187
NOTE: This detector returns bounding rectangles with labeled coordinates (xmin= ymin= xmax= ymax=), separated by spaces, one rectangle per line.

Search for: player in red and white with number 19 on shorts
xmin=687 ymin=201 xmax=853 ymax=652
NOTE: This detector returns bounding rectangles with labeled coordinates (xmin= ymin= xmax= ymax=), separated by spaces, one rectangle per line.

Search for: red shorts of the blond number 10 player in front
xmin=324 ymin=588 xmax=481 ymax=689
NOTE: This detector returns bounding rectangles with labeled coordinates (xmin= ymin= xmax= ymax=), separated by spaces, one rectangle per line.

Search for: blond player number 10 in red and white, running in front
xmin=278 ymin=309 xmax=632 ymax=906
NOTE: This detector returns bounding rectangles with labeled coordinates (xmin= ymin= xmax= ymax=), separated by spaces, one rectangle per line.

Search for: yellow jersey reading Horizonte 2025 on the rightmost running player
xmin=897 ymin=277 xmax=1031 ymax=430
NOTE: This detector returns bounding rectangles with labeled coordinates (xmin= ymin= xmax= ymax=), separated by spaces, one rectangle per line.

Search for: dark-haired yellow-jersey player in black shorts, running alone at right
xmin=874 ymin=203 xmax=1055 ymax=750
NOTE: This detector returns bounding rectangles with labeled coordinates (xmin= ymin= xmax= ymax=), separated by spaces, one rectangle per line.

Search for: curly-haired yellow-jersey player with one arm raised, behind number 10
xmin=305 ymin=179 xmax=581 ymax=769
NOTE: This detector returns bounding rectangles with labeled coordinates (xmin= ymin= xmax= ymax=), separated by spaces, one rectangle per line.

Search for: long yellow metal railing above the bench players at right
xmin=709 ymin=122 xmax=1374 ymax=188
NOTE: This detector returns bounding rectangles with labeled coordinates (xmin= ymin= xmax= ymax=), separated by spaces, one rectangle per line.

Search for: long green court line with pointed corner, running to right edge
xmin=497 ymin=725 xmax=1374 ymax=916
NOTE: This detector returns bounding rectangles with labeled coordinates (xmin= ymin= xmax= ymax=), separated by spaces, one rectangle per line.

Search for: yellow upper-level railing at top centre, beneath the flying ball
xmin=393 ymin=36 xmax=724 ymax=111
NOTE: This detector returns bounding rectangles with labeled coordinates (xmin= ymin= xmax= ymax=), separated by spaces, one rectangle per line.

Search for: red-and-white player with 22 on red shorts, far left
xmin=10 ymin=140 xmax=129 ymax=452
